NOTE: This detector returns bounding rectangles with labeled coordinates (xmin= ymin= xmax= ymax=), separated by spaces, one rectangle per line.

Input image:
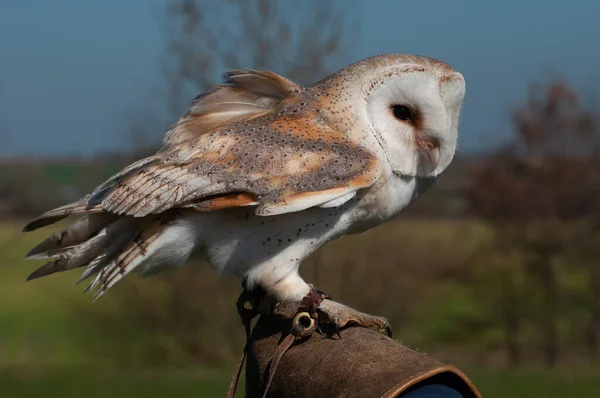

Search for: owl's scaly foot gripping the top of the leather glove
xmin=318 ymin=299 xmax=392 ymax=338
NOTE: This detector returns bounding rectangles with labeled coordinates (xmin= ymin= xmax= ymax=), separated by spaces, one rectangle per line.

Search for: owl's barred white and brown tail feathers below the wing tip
xmin=27 ymin=211 xmax=195 ymax=299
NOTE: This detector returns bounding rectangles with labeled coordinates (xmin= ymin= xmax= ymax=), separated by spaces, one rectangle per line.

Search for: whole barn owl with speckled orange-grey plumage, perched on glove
xmin=24 ymin=54 xmax=465 ymax=329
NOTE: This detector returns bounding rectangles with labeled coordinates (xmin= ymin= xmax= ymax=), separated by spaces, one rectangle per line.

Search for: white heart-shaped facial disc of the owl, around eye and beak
xmin=364 ymin=67 xmax=465 ymax=177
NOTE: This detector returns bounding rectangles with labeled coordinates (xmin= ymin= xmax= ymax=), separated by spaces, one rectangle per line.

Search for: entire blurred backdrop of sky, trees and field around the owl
xmin=0 ymin=0 xmax=600 ymax=397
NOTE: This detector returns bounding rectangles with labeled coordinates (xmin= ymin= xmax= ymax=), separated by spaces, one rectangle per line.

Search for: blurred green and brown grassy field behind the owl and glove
xmin=0 ymin=218 xmax=600 ymax=397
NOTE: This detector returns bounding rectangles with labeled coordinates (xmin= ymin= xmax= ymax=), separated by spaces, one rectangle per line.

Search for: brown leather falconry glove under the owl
xmin=241 ymin=305 xmax=481 ymax=398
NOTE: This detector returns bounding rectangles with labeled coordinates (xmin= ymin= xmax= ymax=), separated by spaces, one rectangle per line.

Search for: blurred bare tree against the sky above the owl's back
xmin=131 ymin=0 xmax=357 ymax=152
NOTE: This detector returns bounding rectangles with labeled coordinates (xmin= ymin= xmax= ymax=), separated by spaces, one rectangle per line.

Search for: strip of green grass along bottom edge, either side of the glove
xmin=0 ymin=365 xmax=600 ymax=398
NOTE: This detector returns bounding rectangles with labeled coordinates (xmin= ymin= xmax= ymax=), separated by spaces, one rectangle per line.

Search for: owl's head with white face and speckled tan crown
xmin=318 ymin=54 xmax=465 ymax=177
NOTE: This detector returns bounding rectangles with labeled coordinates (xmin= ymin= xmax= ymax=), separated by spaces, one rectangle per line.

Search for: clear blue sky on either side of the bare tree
xmin=0 ymin=0 xmax=600 ymax=156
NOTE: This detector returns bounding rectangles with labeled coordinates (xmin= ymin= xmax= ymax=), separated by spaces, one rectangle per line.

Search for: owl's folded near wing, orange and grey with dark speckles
xmin=25 ymin=76 xmax=381 ymax=230
